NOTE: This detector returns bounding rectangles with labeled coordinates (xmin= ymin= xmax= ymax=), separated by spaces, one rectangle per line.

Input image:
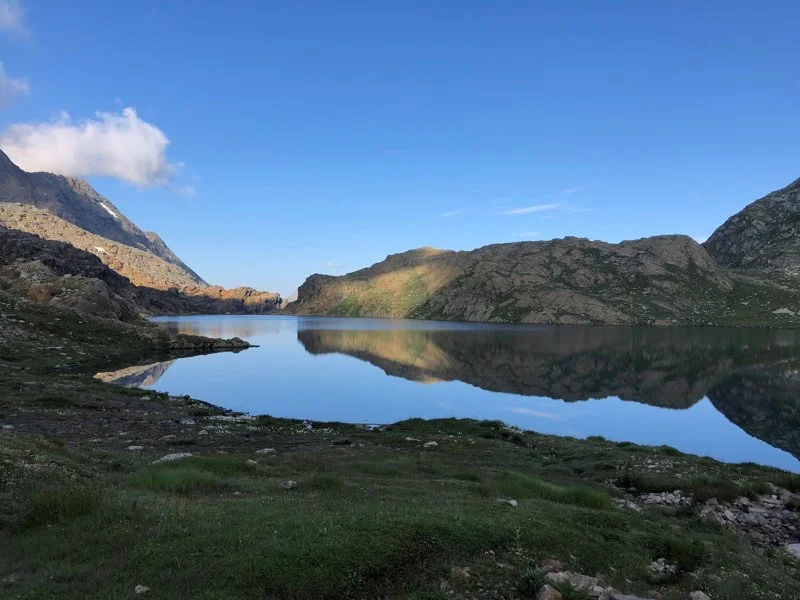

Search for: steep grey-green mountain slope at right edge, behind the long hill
xmin=703 ymin=179 xmax=800 ymax=278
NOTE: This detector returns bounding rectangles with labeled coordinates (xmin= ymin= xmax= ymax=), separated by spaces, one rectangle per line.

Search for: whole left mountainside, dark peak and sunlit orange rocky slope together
xmin=0 ymin=151 xmax=281 ymax=314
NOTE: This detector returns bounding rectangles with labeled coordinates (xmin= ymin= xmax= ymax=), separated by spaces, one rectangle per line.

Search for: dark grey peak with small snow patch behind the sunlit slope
xmin=0 ymin=151 xmax=205 ymax=285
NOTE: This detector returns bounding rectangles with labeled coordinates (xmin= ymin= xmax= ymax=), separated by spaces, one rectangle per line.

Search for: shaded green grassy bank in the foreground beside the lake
xmin=0 ymin=290 xmax=800 ymax=600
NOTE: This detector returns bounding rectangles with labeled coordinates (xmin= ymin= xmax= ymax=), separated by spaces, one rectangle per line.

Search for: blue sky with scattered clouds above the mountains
xmin=0 ymin=0 xmax=800 ymax=295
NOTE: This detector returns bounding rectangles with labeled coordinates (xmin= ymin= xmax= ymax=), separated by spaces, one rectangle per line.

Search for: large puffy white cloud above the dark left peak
xmin=0 ymin=107 xmax=181 ymax=187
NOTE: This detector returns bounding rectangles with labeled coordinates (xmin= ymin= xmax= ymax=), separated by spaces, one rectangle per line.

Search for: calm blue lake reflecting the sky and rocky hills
xmin=97 ymin=316 xmax=800 ymax=472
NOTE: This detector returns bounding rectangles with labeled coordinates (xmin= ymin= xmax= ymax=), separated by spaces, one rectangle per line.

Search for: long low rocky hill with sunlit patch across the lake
xmin=287 ymin=235 xmax=800 ymax=325
